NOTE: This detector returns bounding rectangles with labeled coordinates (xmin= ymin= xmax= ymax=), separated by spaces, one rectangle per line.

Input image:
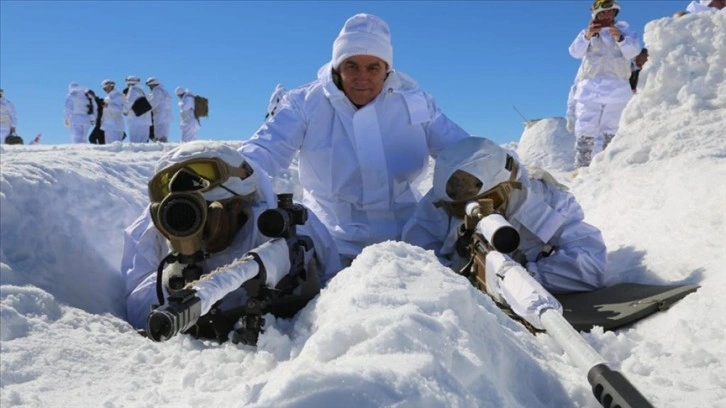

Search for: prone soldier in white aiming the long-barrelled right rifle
xmin=403 ymin=137 xmax=609 ymax=327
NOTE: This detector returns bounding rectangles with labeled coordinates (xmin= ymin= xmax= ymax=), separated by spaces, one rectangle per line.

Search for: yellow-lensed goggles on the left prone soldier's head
xmin=149 ymin=157 xmax=253 ymax=202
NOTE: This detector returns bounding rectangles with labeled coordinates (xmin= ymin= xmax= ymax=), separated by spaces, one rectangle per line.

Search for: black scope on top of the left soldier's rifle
xmin=257 ymin=193 xmax=308 ymax=238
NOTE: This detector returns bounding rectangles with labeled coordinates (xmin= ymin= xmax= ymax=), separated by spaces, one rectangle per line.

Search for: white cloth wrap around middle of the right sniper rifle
xmin=486 ymin=251 xmax=562 ymax=329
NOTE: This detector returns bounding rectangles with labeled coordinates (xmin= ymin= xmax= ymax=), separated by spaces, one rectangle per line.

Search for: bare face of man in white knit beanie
xmin=338 ymin=55 xmax=388 ymax=106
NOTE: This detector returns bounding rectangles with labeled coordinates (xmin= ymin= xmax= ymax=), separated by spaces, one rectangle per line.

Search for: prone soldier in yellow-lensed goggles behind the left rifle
xmin=121 ymin=141 xmax=341 ymax=340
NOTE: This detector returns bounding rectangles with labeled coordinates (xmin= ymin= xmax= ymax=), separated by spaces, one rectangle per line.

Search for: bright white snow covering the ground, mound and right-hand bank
xmin=0 ymin=12 xmax=726 ymax=408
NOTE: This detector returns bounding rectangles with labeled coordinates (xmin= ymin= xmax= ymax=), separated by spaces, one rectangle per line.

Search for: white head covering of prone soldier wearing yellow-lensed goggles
xmin=154 ymin=140 xmax=258 ymax=201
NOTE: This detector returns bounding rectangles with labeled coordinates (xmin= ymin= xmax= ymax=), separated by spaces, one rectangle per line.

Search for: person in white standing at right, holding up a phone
xmin=569 ymin=0 xmax=642 ymax=167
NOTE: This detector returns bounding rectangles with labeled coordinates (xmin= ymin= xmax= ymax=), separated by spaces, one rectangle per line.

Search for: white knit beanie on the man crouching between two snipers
xmin=331 ymin=13 xmax=393 ymax=70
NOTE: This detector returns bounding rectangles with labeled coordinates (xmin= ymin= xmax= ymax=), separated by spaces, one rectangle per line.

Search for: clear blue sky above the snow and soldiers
xmin=0 ymin=0 xmax=688 ymax=144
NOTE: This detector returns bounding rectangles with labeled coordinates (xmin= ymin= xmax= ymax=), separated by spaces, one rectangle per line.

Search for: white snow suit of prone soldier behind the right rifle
xmin=403 ymin=138 xmax=607 ymax=293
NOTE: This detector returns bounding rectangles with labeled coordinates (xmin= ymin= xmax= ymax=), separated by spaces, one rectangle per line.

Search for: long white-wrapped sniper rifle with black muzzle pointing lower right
xmin=458 ymin=199 xmax=652 ymax=408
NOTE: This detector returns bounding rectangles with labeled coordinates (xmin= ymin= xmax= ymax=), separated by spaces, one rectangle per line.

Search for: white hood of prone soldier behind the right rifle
xmin=433 ymin=137 xmax=514 ymax=202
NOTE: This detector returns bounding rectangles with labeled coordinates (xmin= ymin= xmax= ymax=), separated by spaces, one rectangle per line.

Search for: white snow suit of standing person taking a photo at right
xmin=569 ymin=21 xmax=642 ymax=167
